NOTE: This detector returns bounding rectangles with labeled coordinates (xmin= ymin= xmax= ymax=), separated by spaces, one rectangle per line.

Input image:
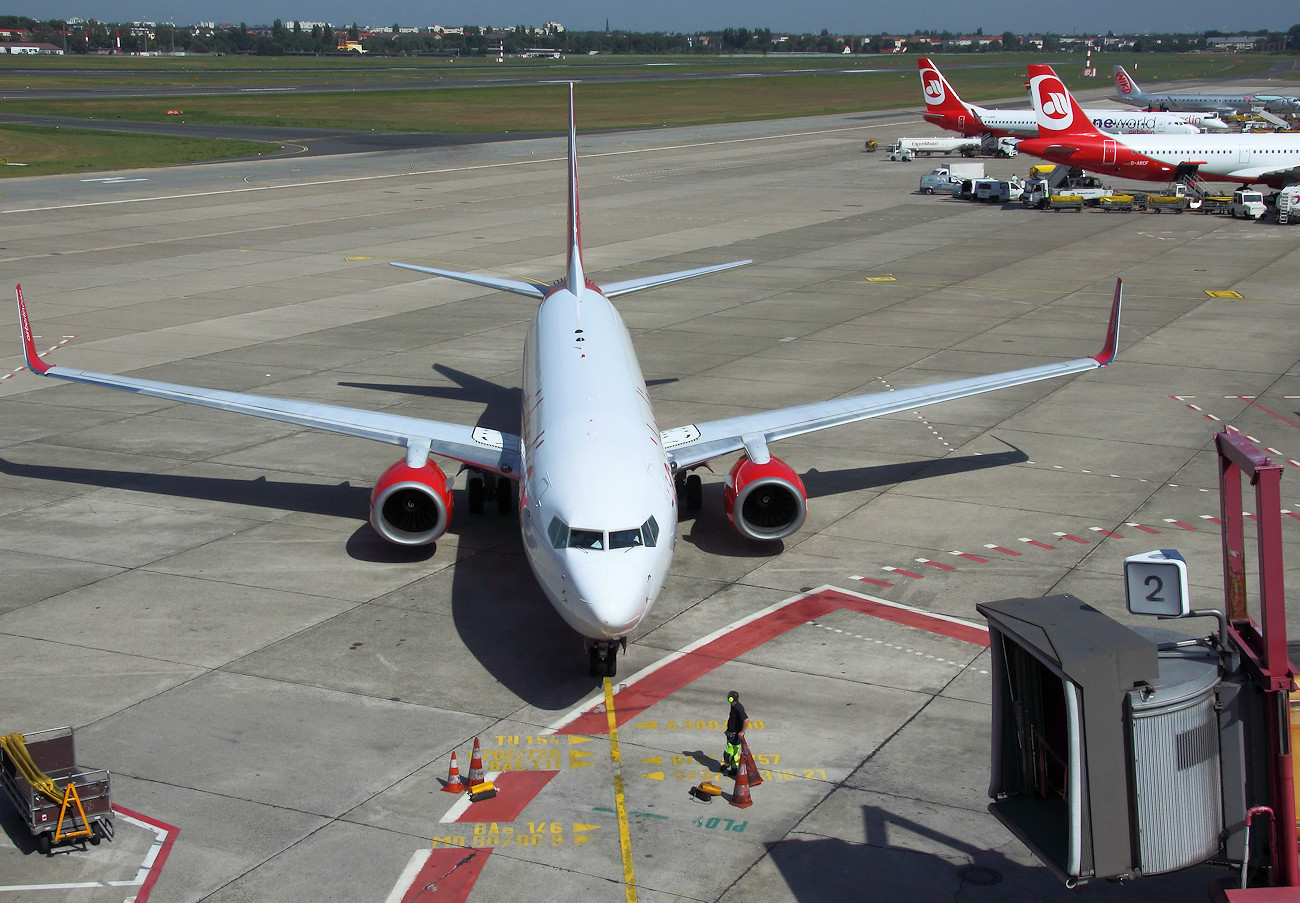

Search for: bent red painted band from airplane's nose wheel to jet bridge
xmin=556 ymin=590 xmax=989 ymax=737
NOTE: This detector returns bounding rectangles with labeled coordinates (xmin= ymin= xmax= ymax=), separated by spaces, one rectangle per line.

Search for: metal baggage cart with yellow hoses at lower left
xmin=0 ymin=728 xmax=113 ymax=854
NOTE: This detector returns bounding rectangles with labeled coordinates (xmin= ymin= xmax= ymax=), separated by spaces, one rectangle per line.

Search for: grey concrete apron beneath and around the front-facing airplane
xmin=0 ymin=102 xmax=1300 ymax=903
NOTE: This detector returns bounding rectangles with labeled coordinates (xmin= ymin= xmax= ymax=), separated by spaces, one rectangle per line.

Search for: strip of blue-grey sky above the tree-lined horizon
xmin=20 ymin=0 xmax=1300 ymax=34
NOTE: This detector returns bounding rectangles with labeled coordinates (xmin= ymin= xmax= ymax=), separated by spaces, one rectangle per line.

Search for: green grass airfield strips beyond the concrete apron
xmin=0 ymin=53 xmax=1271 ymax=177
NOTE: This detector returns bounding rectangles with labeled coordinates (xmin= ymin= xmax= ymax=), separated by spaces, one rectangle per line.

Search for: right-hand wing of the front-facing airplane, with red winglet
xmin=662 ymin=279 xmax=1123 ymax=469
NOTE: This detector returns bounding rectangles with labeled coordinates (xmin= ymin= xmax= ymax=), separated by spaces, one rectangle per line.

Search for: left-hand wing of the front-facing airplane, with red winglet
xmin=17 ymin=286 xmax=520 ymax=479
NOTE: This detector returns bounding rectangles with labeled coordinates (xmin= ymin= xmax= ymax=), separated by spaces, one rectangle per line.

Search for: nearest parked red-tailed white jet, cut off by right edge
xmin=1019 ymin=62 xmax=1300 ymax=188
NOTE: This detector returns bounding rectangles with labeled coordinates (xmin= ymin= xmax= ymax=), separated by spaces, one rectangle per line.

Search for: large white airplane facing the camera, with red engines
xmin=17 ymin=86 xmax=1122 ymax=677
